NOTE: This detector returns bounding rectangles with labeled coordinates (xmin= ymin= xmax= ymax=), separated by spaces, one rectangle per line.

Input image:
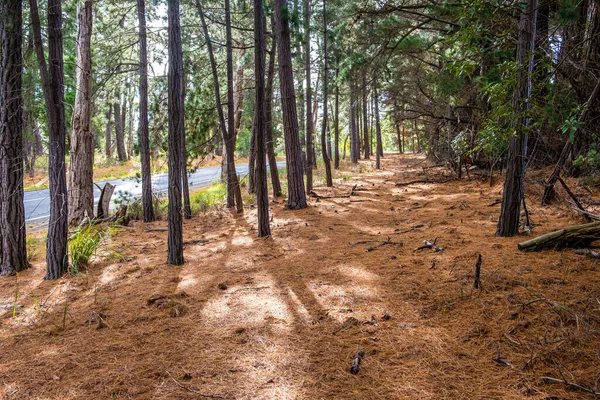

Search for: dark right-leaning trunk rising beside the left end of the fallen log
xmin=496 ymin=0 xmax=538 ymax=237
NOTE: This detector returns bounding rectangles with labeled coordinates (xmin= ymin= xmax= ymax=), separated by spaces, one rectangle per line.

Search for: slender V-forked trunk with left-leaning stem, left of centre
xmin=196 ymin=0 xmax=243 ymax=212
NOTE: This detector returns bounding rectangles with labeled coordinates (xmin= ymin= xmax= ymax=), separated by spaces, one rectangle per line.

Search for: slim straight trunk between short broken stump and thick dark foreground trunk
xmin=137 ymin=0 xmax=154 ymax=222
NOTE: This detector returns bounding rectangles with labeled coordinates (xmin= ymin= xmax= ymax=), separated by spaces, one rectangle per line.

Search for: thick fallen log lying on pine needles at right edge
xmin=518 ymin=222 xmax=600 ymax=251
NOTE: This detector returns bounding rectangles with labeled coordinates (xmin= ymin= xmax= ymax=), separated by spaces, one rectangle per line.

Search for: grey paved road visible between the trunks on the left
xmin=25 ymin=162 xmax=285 ymax=224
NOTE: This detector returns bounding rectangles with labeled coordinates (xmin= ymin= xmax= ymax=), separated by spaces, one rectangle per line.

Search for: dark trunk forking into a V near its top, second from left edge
xmin=29 ymin=0 xmax=68 ymax=279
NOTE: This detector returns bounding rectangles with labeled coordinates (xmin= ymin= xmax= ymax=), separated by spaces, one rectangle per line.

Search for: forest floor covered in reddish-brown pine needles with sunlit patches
xmin=0 ymin=154 xmax=600 ymax=399
